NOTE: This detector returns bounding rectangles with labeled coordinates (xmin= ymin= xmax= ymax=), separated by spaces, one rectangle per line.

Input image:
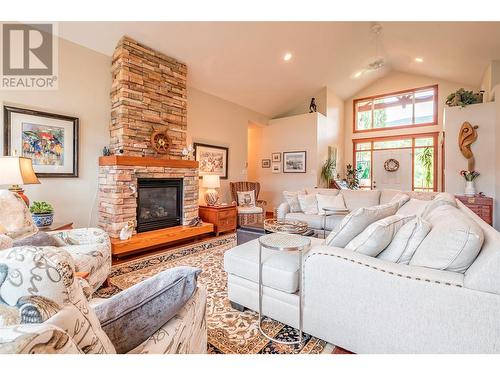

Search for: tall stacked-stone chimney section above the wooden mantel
xmin=110 ymin=37 xmax=187 ymax=159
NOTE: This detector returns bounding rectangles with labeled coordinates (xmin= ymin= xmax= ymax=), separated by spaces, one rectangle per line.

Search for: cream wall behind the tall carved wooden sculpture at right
xmin=444 ymin=102 xmax=496 ymax=197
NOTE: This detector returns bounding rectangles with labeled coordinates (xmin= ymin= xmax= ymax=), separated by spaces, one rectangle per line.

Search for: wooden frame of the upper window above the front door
xmin=352 ymin=84 xmax=439 ymax=133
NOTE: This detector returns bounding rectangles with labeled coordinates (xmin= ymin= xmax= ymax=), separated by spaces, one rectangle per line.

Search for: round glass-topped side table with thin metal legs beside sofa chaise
xmin=258 ymin=233 xmax=311 ymax=346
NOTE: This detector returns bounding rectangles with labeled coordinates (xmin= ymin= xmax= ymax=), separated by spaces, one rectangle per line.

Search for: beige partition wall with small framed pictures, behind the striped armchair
xmin=248 ymin=113 xmax=327 ymax=211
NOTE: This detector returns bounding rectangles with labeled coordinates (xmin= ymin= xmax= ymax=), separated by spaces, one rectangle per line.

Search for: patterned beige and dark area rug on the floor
xmin=97 ymin=234 xmax=333 ymax=354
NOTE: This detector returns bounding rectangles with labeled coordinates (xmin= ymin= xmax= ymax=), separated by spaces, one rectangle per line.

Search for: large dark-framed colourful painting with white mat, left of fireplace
xmin=3 ymin=106 xmax=79 ymax=177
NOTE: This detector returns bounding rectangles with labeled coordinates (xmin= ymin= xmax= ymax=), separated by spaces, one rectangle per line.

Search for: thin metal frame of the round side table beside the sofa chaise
xmin=258 ymin=234 xmax=311 ymax=347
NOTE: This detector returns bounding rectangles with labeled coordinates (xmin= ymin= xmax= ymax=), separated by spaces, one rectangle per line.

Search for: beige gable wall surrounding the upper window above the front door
xmin=343 ymin=72 xmax=478 ymax=190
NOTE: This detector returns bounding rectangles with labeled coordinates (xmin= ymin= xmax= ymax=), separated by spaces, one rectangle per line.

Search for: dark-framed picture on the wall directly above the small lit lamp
xmin=193 ymin=143 xmax=229 ymax=179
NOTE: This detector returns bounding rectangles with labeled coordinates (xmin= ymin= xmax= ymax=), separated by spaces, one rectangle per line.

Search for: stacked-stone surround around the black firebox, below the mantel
xmin=99 ymin=165 xmax=198 ymax=238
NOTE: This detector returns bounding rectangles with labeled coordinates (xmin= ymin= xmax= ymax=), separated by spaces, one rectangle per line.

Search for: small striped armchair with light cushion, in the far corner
xmin=230 ymin=181 xmax=267 ymax=225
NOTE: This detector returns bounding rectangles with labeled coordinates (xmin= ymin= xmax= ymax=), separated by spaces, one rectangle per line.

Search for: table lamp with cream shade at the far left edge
xmin=0 ymin=156 xmax=40 ymax=206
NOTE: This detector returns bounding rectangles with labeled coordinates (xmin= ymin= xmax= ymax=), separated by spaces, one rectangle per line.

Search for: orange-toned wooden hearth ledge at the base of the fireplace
xmin=111 ymin=223 xmax=214 ymax=257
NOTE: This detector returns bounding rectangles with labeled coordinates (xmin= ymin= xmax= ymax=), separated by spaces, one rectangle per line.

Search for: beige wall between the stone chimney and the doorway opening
xmin=187 ymin=87 xmax=268 ymax=204
